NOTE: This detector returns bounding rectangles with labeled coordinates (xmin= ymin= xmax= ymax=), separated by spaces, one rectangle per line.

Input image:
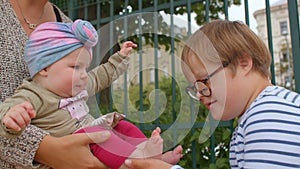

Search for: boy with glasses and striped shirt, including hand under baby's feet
xmin=125 ymin=20 xmax=300 ymax=169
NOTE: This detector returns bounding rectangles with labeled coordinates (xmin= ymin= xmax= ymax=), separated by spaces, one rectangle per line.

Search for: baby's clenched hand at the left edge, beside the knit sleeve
xmin=2 ymin=102 xmax=36 ymax=131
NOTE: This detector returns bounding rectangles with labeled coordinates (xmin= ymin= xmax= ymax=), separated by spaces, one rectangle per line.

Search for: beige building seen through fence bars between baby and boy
xmin=113 ymin=25 xmax=187 ymax=90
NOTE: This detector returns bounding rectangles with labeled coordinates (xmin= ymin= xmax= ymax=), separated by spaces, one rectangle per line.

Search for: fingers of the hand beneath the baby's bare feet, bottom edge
xmin=125 ymin=159 xmax=172 ymax=169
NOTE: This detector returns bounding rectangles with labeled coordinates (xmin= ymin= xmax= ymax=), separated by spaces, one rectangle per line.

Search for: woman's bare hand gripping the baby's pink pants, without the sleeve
xmin=35 ymin=131 xmax=110 ymax=169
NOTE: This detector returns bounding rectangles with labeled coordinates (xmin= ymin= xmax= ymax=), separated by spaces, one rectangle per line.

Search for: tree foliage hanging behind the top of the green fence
xmin=51 ymin=0 xmax=241 ymax=49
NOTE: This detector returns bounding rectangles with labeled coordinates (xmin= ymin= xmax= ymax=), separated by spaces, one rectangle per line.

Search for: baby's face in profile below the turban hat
xmin=43 ymin=47 xmax=91 ymax=97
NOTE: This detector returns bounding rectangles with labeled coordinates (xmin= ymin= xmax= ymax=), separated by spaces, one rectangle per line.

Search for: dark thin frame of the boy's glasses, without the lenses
xmin=185 ymin=62 xmax=229 ymax=101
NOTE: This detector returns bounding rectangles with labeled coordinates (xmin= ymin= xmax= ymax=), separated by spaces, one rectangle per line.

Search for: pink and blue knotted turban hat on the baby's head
xmin=24 ymin=19 xmax=98 ymax=77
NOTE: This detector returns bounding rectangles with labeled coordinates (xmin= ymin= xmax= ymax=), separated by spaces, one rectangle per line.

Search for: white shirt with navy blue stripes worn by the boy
xmin=230 ymin=86 xmax=300 ymax=169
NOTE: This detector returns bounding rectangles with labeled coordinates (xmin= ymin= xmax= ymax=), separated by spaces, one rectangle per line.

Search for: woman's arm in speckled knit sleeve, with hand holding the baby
xmin=0 ymin=125 xmax=109 ymax=169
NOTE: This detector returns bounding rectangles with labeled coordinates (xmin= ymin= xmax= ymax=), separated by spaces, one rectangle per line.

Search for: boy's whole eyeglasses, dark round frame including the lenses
xmin=185 ymin=62 xmax=229 ymax=101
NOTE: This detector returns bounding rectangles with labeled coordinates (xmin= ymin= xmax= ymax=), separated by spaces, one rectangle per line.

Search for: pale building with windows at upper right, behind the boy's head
xmin=253 ymin=0 xmax=299 ymax=89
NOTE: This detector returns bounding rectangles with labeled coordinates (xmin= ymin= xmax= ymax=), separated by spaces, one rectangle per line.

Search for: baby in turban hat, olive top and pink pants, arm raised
xmin=0 ymin=20 xmax=182 ymax=169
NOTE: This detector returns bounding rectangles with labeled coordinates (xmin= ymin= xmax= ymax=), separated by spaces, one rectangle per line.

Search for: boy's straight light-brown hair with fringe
xmin=182 ymin=20 xmax=271 ymax=79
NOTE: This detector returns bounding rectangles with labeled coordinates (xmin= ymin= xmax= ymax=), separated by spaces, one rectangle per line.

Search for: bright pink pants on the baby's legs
xmin=75 ymin=120 xmax=147 ymax=169
